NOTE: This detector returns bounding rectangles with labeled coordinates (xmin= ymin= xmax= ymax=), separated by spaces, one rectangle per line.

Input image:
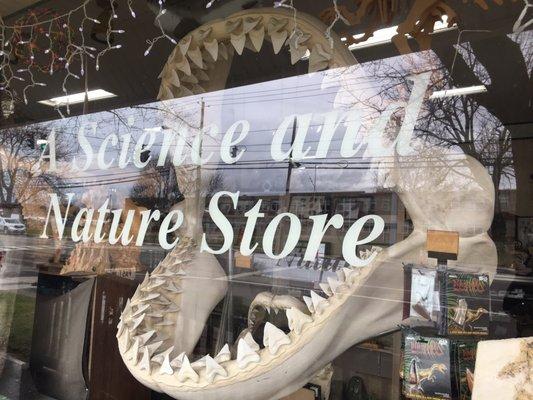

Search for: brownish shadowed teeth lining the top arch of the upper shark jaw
xmin=157 ymin=16 xmax=333 ymax=100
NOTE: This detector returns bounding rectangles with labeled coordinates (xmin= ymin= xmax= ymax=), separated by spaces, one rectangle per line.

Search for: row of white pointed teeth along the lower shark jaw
xmin=117 ymin=258 xmax=361 ymax=384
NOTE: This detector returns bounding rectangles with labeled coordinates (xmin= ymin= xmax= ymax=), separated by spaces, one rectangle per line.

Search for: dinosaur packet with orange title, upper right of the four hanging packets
xmin=445 ymin=272 xmax=490 ymax=336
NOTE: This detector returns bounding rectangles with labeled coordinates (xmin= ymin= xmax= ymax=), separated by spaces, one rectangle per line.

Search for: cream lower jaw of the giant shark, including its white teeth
xmin=117 ymin=231 xmax=432 ymax=400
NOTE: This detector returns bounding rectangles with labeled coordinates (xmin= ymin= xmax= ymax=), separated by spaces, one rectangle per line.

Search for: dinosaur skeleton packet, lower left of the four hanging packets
xmin=402 ymin=334 xmax=452 ymax=400
